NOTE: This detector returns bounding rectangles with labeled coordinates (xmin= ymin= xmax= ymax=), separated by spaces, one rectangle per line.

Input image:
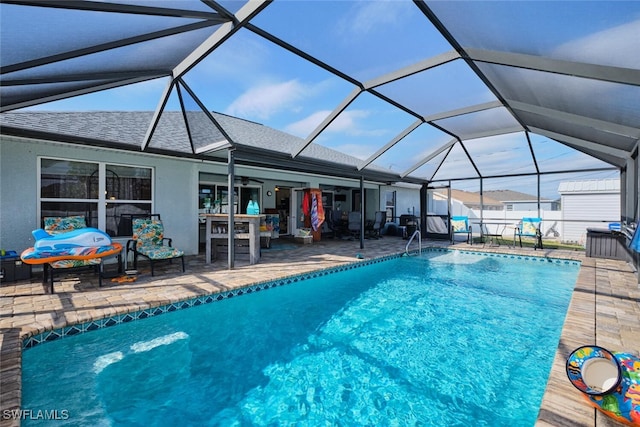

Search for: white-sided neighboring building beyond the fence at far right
xmin=558 ymin=178 xmax=620 ymax=244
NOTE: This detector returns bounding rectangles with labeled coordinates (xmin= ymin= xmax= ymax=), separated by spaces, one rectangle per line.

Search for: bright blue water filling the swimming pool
xmin=22 ymin=251 xmax=579 ymax=427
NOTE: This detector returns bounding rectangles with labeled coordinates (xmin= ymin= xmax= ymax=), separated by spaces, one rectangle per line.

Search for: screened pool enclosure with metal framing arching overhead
xmin=0 ymin=0 xmax=640 ymax=258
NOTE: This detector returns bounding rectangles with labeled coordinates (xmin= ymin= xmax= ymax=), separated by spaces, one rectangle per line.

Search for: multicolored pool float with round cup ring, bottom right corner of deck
xmin=566 ymin=345 xmax=640 ymax=426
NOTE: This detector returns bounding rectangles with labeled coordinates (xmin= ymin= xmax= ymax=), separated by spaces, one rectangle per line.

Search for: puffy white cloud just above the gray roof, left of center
xmin=225 ymin=80 xmax=309 ymax=120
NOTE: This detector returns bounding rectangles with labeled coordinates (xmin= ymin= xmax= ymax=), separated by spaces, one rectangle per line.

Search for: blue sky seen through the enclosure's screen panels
xmin=21 ymin=0 xmax=640 ymax=197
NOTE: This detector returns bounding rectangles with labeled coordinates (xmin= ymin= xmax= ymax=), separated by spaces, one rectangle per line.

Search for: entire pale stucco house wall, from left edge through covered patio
xmin=0 ymin=136 xmax=388 ymax=255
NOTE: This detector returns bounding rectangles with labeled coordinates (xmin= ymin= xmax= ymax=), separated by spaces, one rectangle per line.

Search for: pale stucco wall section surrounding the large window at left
xmin=0 ymin=137 xmax=198 ymax=254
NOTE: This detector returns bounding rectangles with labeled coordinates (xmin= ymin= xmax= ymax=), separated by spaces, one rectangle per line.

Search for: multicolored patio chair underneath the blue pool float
xmin=42 ymin=215 xmax=117 ymax=294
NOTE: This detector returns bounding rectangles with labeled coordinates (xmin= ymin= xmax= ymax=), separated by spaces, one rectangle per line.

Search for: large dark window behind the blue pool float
xmin=40 ymin=158 xmax=153 ymax=237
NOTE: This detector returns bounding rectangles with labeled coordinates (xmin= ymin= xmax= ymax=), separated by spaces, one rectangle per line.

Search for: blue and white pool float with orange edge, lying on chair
xmin=20 ymin=227 xmax=122 ymax=264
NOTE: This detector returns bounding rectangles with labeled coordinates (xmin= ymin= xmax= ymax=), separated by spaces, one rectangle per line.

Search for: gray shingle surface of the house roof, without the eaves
xmin=0 ymin=111 xmax=388 ymax=176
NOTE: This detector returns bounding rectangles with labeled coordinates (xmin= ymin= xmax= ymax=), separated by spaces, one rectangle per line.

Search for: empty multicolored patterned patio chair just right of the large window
xmin=127 ymin=218 xmax=184 ymax=276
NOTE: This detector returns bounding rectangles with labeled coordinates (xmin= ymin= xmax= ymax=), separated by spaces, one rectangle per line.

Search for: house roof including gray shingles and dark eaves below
xmin=0 ymin=111 xmax=404 ymax=182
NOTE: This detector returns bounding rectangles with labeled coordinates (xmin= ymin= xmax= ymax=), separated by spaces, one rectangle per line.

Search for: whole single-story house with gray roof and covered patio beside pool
xmin=0 ymin=111 xmax=419 ymax=255
